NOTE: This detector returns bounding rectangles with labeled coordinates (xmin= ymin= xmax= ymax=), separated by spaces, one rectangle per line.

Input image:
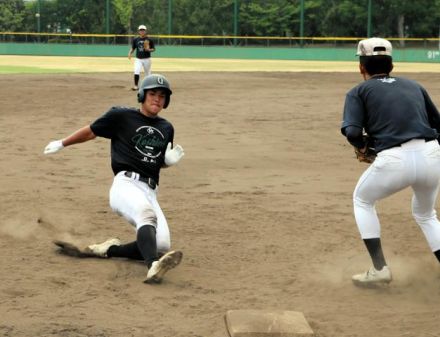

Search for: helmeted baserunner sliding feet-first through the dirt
xmin=44 ymin=75 xmax=184 ymax=283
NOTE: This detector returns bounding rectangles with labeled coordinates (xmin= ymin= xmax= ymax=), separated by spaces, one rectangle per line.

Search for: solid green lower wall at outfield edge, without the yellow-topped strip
xmin=0 ymin=43 xmax=440 ymax=63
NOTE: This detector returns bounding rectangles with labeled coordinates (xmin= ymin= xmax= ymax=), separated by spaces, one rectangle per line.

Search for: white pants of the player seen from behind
xmin=353 ymin=139 xmax=440 ymax=252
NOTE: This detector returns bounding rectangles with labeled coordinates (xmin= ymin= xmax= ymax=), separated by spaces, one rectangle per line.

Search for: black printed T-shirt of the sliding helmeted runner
xmin=90 ymin=107 xmax=174 ymax=183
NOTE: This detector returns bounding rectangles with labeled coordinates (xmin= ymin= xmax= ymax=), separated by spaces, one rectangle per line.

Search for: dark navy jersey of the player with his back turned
xmin=341 ymin=76 xmax=440 ymax=152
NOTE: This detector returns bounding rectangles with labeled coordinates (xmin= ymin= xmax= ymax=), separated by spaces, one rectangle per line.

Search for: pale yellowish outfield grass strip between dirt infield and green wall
xmin=0 ymin=55 xmax=440 ymax=74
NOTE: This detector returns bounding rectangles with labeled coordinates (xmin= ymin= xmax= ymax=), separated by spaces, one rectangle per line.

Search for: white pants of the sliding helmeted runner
xmin=110 ymin=171 xmax=171 ymax=253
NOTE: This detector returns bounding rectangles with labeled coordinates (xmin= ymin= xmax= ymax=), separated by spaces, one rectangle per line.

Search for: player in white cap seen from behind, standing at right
xmin=341 ymin=38 xmax=440 ymax=285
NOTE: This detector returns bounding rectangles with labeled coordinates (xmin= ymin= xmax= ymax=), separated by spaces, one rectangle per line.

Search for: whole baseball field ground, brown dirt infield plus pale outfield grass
xmin=0 ymin=56 xmax=440 ymax=337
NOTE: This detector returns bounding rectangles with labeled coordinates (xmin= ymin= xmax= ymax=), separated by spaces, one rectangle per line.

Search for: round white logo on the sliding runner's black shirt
xmin=131 ymin=126 xmax=165 ymax=162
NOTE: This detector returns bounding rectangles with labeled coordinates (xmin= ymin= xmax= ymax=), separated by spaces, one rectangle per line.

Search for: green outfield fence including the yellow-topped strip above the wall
xmin=0 ymin=32 xmax=440 ymax=63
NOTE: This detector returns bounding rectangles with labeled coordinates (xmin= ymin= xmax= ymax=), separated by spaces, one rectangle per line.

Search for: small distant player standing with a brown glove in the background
xmin=128 ymin=25 xmax=156 ymax=90
